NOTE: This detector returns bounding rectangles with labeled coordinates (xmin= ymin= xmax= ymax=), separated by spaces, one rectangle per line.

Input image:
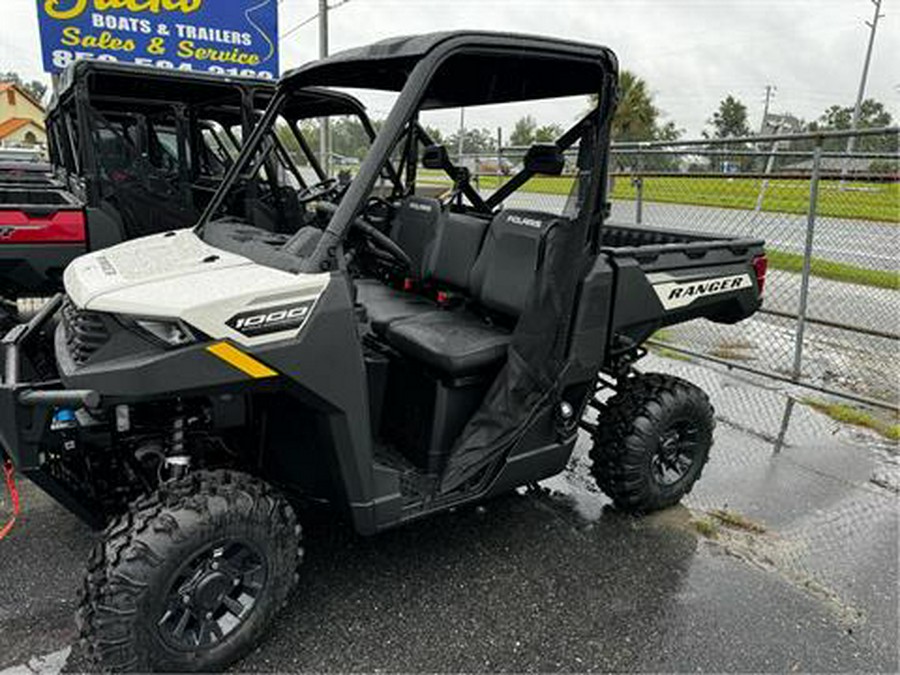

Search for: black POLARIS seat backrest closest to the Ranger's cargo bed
xmin=469 ymin=209 xmax=559 ymax=318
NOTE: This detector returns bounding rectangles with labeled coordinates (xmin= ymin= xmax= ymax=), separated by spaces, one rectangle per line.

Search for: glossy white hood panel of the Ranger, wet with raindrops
xmin=64 ymin=229 xmax=331 ymax=346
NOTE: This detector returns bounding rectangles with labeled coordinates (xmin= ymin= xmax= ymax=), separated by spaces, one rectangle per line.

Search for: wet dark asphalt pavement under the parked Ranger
xmin=0 ymin=356 xmax=900 ymax=675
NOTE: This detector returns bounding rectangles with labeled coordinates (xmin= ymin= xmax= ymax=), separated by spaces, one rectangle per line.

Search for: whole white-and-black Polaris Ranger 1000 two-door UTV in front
xmin=0 ymin=32 xmax=765 ymax=671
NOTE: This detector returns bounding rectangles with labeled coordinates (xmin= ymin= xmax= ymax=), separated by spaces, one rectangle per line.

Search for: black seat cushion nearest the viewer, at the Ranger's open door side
xmin=385 ymin=311 xmax=512 ymax=377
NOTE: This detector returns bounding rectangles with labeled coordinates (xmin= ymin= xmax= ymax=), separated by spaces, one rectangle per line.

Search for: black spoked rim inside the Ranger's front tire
xmin=157 ymin=541 xmax=267 ymax=651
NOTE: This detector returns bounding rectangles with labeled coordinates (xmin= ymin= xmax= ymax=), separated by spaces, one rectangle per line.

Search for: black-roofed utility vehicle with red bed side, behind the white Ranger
xmin=0 ymin=61 xmax=382 ymax=328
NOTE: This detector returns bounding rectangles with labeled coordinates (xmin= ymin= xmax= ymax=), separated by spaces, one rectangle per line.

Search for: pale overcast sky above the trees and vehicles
xmin=0 ymin=0 xmax=900 ymax=137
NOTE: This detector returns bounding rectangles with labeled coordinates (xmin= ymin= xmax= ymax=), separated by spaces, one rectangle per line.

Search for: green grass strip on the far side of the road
xmin=421 ymin=170 xmax=900 ymax=223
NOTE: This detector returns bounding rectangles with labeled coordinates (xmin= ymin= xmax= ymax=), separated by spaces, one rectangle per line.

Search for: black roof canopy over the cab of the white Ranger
xmin=282 ymin=31 xmax=618 ymax=109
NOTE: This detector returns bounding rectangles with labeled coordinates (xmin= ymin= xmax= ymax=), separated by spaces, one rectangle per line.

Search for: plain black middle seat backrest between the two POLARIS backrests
xmin=424 ymin=213 xmax=490 ymax=290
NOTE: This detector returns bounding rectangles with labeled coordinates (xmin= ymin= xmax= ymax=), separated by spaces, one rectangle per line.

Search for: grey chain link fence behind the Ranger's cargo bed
xmin=422 ymin=128 xmax=900 ymax=445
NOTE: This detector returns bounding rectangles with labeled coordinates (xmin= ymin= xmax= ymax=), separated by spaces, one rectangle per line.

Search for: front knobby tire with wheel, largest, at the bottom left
xmin=77 ymin=471 xmax=301 ymax=672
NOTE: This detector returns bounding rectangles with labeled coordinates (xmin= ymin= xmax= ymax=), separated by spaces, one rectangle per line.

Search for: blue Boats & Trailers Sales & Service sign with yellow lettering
xmin=37 ymin=0 xmax=279 ymax=79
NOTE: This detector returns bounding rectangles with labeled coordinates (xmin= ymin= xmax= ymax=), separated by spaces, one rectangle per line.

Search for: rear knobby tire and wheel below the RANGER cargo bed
xmin=590 ymin=373 xmax=715 ymax=513
